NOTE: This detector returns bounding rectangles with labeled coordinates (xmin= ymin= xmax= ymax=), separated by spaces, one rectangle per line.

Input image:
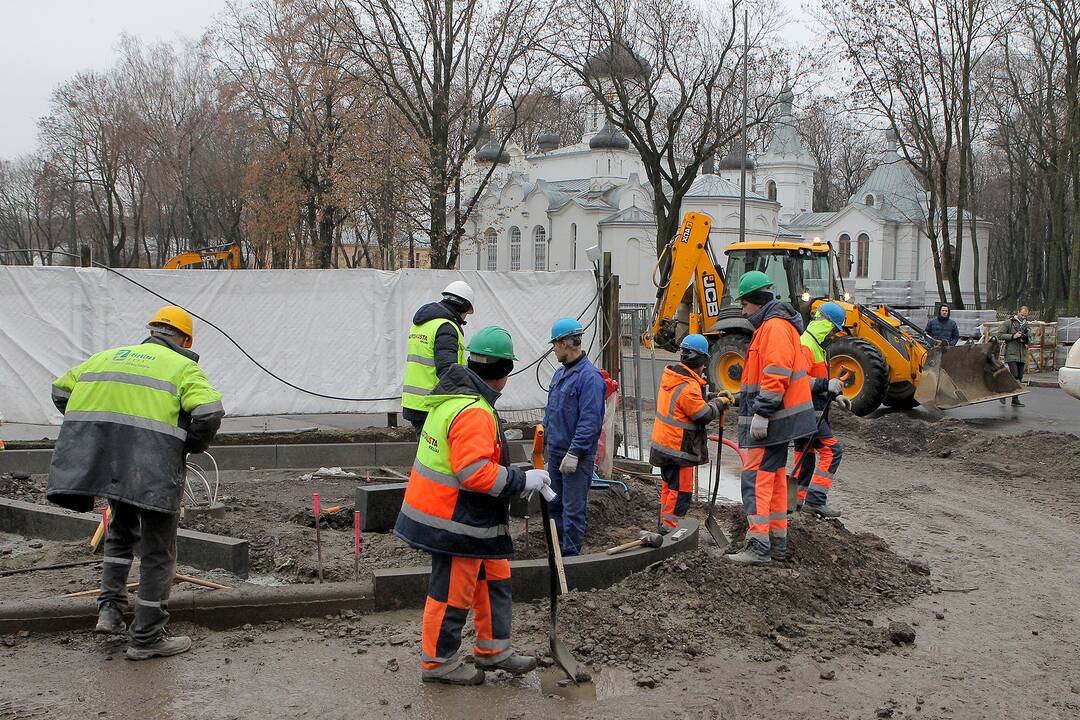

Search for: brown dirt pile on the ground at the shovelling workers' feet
xmin=518 ymin=507 xmax=930 ymax=681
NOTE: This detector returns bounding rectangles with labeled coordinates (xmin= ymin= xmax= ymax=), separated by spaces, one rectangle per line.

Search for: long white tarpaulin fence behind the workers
xmin=0 ymin=267 xmax=597 ymax=424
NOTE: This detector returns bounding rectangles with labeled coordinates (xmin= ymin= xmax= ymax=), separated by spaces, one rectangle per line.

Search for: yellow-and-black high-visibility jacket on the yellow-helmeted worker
xmin=46 ymin=337 xmax=225 ymax=513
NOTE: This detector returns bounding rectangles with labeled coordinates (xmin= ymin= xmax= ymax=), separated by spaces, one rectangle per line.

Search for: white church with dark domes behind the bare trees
xmin=458 ymin=56 xmax=990 ymax=305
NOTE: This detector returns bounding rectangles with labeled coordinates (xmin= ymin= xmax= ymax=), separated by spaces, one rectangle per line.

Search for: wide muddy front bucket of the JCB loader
xmin=915 ymin=344 xmax=1027 ymax=410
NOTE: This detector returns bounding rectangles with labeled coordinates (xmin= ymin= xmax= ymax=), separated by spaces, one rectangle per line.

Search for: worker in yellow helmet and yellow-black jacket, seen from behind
xmin=46 ymin=307 xmax=225 ymax=660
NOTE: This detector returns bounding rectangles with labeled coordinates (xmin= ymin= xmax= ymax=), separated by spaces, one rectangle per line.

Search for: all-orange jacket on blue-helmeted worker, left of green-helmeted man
xmin=649 ymin=363 xmax=717 ymax=467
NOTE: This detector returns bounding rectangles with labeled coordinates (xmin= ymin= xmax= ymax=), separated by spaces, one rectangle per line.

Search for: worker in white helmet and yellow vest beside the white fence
xmin=402 ymin=280 xmax=475 ymax=432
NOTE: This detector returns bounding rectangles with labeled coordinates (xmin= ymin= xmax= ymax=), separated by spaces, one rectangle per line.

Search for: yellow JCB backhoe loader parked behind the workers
xmin=643 ymin=213 xmax=1024 ymax=416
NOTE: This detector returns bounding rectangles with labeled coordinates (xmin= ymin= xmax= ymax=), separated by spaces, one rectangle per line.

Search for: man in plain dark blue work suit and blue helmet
xmin=543 ymin=317 xmax=607 ymax=555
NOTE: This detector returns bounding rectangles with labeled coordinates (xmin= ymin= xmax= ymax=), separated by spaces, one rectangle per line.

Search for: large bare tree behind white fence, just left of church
xmin=336 ymin=0 xmax=565 ymax=268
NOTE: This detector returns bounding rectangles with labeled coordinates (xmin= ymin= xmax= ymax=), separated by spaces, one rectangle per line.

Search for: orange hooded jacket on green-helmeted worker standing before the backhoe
xmin=739 ymin=300 xmax=818 ymax=448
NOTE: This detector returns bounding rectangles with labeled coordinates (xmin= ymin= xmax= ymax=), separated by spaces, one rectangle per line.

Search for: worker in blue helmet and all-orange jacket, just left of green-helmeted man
xmin=649 ymin=334 xmax=723 ymax=534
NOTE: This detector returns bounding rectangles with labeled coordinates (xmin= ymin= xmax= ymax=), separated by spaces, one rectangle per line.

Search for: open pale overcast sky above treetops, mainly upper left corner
xmin=0 ymin=0 xmax=812 ymax=158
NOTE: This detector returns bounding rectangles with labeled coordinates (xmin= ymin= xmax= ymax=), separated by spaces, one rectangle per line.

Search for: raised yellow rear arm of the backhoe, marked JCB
xmin=643 ymin=213 xmax=724 ymax=352
